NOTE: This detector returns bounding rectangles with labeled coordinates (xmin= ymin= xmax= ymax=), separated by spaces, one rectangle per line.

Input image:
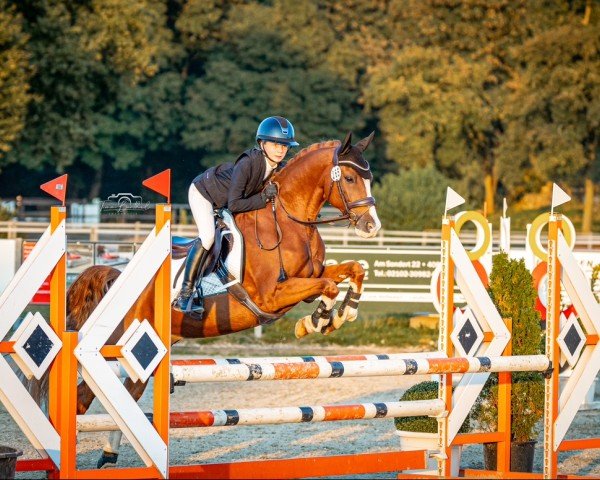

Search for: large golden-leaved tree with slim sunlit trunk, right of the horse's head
xmin=365 ymin=0 xmax=526 ymax=212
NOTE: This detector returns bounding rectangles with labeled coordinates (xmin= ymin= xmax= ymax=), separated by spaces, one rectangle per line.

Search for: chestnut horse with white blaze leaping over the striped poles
xmin=67 ymin=133 xmax=381 ymax=461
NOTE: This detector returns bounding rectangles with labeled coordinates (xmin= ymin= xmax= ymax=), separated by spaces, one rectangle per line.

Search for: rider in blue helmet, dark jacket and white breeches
xmin=173 ymin=117 xmax=298 ymax=313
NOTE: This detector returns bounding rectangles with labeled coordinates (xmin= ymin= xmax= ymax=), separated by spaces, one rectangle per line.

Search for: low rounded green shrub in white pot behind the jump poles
xmin=394 ymin=381 xmax=469 ymax=477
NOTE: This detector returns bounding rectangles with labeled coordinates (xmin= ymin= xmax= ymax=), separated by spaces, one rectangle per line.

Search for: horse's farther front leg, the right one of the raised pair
xmin=321 ymin=261 xmax=365 ymax=335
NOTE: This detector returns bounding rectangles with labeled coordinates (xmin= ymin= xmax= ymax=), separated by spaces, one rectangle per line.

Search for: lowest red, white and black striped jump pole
xmin=77 ymin=399 xmax=444 ymax=432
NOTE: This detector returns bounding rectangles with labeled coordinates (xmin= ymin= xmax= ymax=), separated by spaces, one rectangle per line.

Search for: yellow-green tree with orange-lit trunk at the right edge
xmin=507 ymin=2 xmax=600 ymax=233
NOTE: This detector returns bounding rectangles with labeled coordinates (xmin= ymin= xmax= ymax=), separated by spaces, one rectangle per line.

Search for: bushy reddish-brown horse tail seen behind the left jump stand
xmin=24 ymin=265 xmax=121 ymax=408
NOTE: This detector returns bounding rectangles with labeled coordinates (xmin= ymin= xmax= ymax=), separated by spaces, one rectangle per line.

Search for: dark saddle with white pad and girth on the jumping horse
xmin=171 ymin=208 xmax=281 ymax=325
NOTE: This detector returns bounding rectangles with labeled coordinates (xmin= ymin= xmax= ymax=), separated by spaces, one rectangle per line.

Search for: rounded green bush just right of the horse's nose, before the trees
xmin=373 ymin=167 xmax=450 ymax=230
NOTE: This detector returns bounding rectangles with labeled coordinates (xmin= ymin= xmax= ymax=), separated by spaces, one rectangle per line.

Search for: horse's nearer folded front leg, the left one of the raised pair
xmin=265 ymin=277 xmax=340 ymax=338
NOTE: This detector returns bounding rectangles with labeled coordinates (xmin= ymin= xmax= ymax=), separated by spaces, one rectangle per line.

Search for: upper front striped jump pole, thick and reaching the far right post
xmin=171 ymin=355 xmax=551 ymax=385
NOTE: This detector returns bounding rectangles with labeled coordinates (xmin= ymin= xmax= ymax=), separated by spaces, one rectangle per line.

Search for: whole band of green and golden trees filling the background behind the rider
xmin=0 ymin=0 xmax=600 ymax=210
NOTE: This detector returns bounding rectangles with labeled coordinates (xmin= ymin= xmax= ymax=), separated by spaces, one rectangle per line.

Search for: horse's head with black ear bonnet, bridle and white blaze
xmin=329 ymin=132 xmax=381 ymax=238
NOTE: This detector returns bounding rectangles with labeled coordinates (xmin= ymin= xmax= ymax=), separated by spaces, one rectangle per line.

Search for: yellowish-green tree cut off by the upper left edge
xmin=0 ymin=0 xmax=32 ymax=157
